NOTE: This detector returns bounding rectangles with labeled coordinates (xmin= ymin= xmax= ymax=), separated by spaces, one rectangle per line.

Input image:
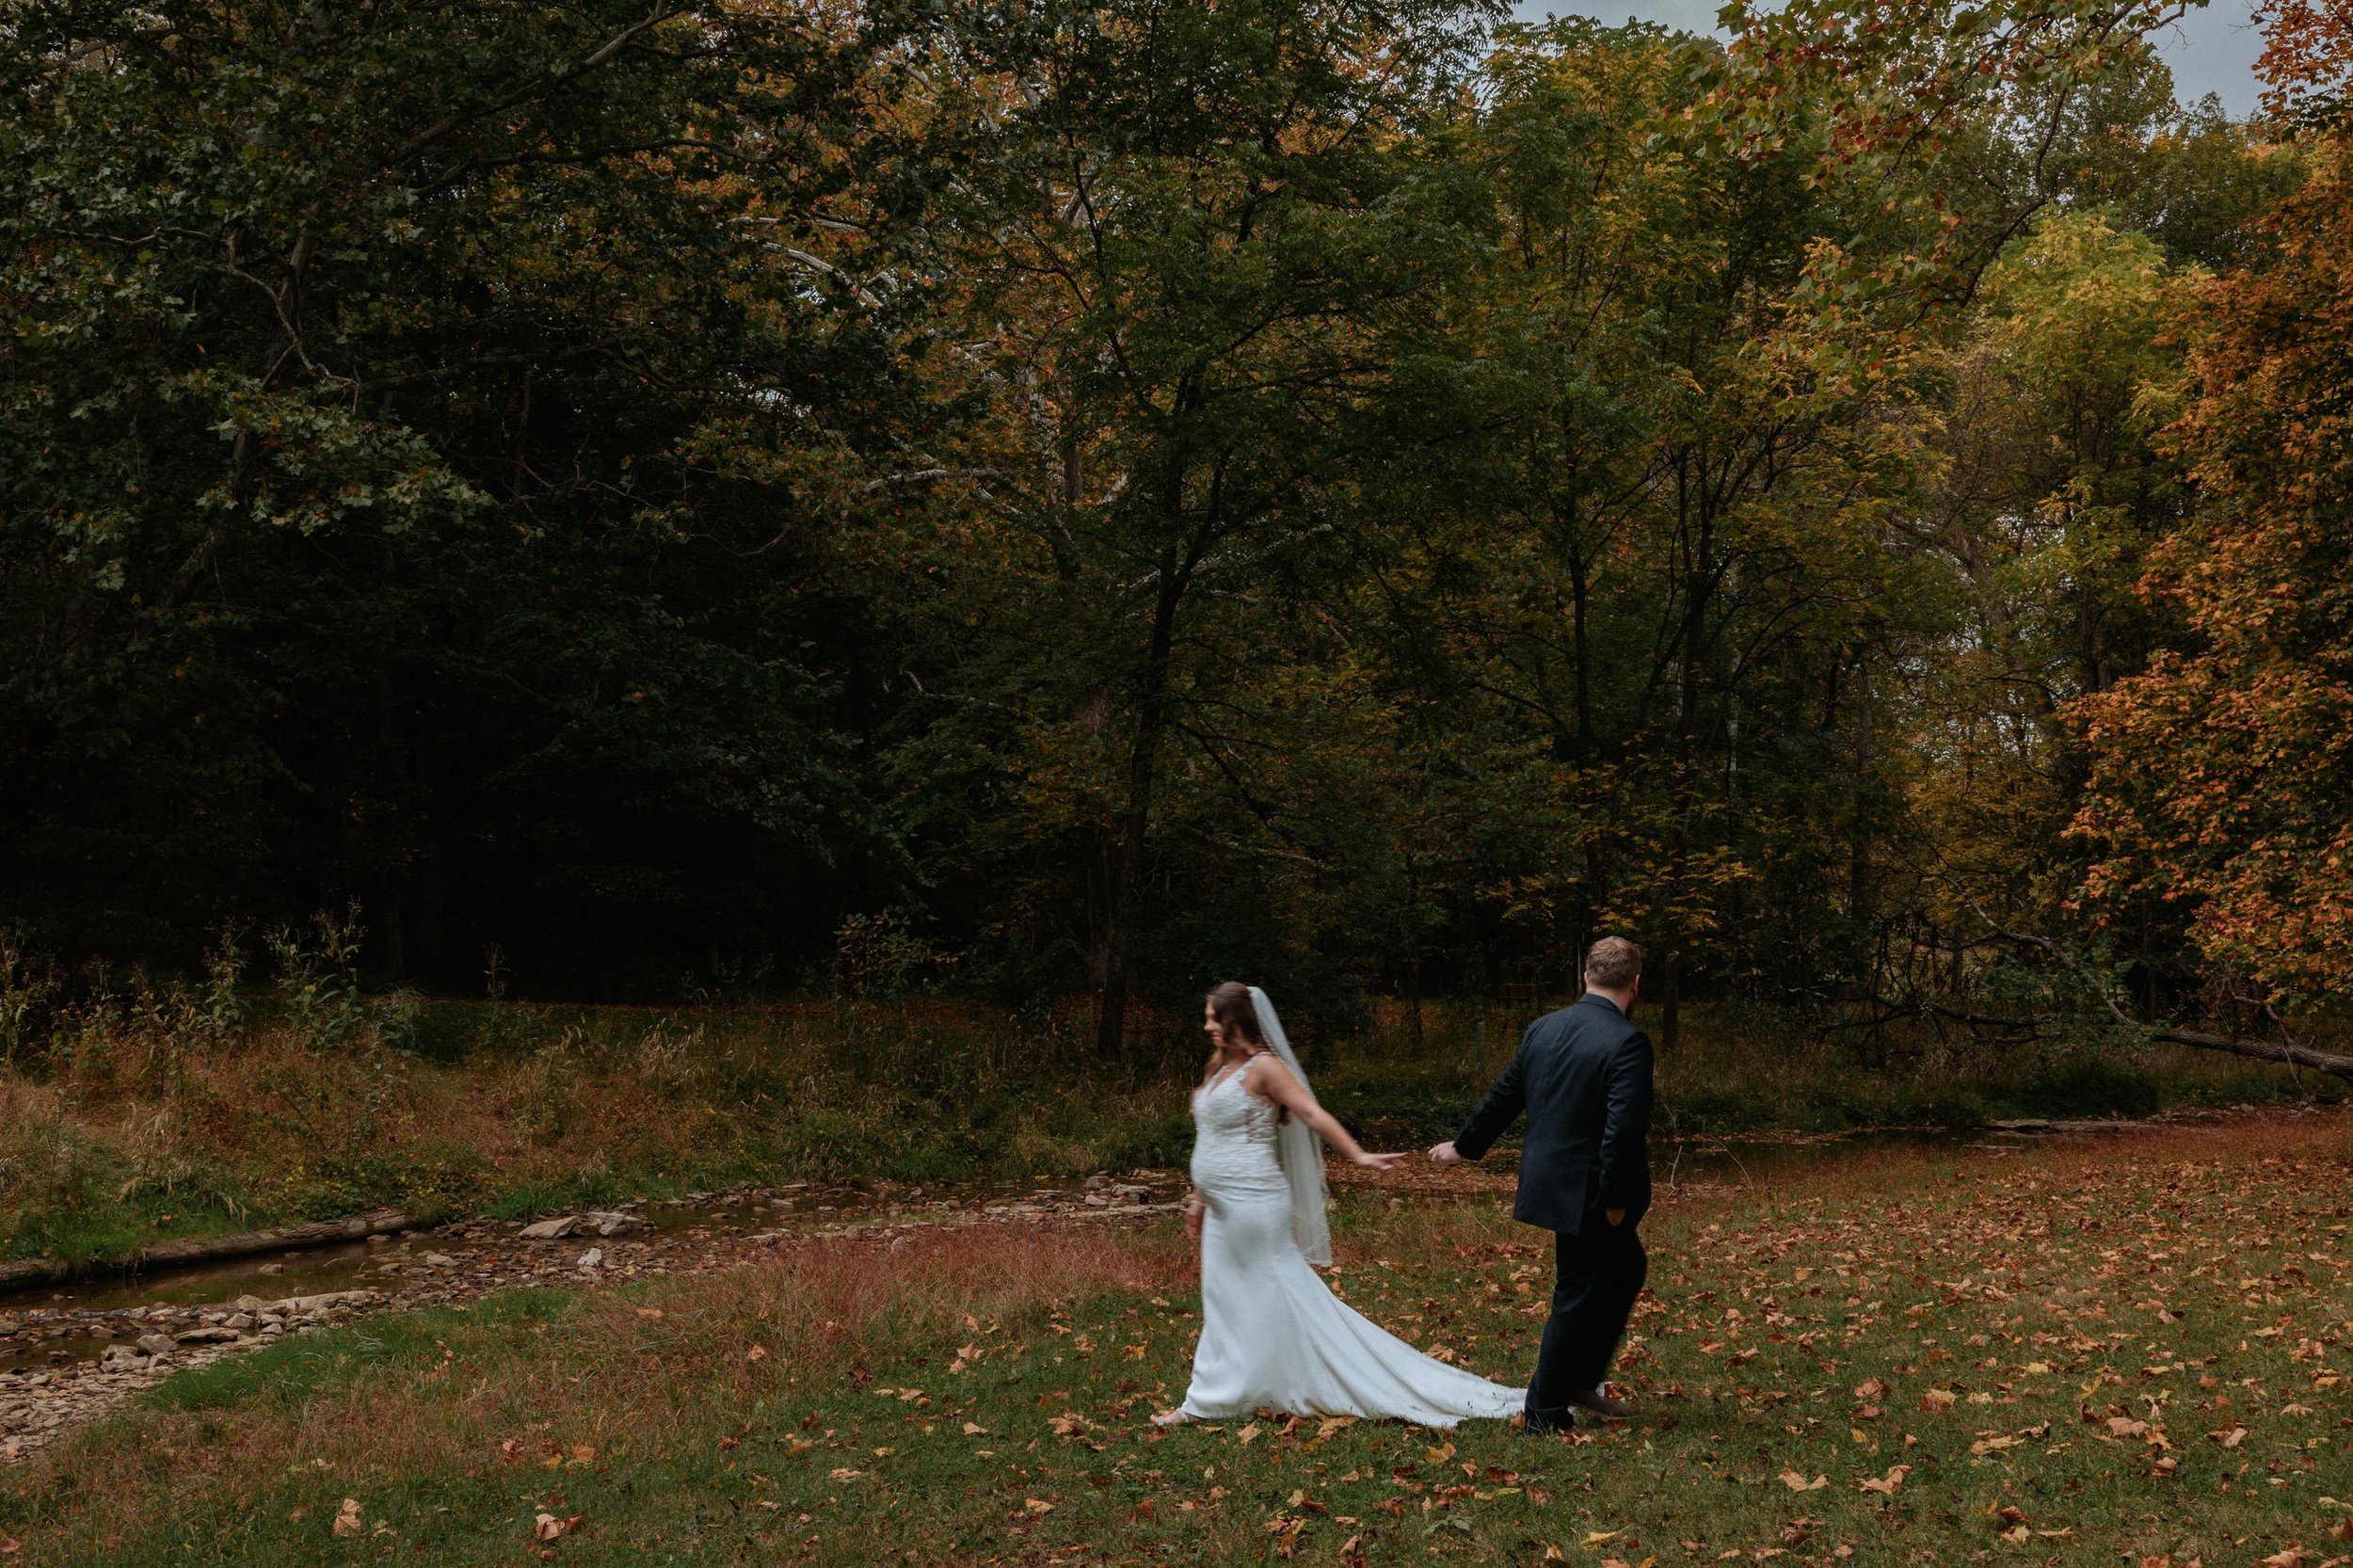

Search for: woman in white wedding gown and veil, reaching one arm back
xmin=1153 ymin=982 xmax=1525 ymax=1427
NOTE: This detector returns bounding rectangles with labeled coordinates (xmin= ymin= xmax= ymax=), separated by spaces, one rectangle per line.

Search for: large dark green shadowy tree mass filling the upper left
xmin=0 ymin=0 xmax=920 ymax=977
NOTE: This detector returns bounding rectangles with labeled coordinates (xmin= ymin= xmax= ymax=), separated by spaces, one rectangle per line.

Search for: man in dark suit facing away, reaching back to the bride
xmin=1431 ymin=937 xmax=1650 ymax=1432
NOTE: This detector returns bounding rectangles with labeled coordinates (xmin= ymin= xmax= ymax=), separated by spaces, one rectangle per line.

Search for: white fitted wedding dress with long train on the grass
xmin=1179 ymin=1069 xmax=1525 ymax=1427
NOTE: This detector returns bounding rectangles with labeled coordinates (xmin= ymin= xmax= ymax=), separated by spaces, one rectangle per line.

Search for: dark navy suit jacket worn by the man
xmin=1454 ymin=991 xmax=1652 ymax=1236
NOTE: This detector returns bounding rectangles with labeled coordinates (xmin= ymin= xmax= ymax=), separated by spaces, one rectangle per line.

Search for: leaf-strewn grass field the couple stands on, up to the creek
xmin=0 ymin=1113 xmax=2353 ymax=1568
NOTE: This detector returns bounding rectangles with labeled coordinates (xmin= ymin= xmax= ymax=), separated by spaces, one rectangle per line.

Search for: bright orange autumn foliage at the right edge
xmin=2073 ymin=113 xmax=2353 ymax=999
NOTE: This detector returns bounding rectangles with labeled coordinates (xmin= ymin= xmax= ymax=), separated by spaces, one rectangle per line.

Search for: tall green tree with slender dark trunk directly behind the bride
xmin=902 ymin=0 xmax=1497 ymax=1055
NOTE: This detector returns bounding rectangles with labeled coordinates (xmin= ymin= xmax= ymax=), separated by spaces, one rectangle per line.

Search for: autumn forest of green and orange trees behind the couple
xmin=0 ymin=0 xmax=2353 ymax=1242
